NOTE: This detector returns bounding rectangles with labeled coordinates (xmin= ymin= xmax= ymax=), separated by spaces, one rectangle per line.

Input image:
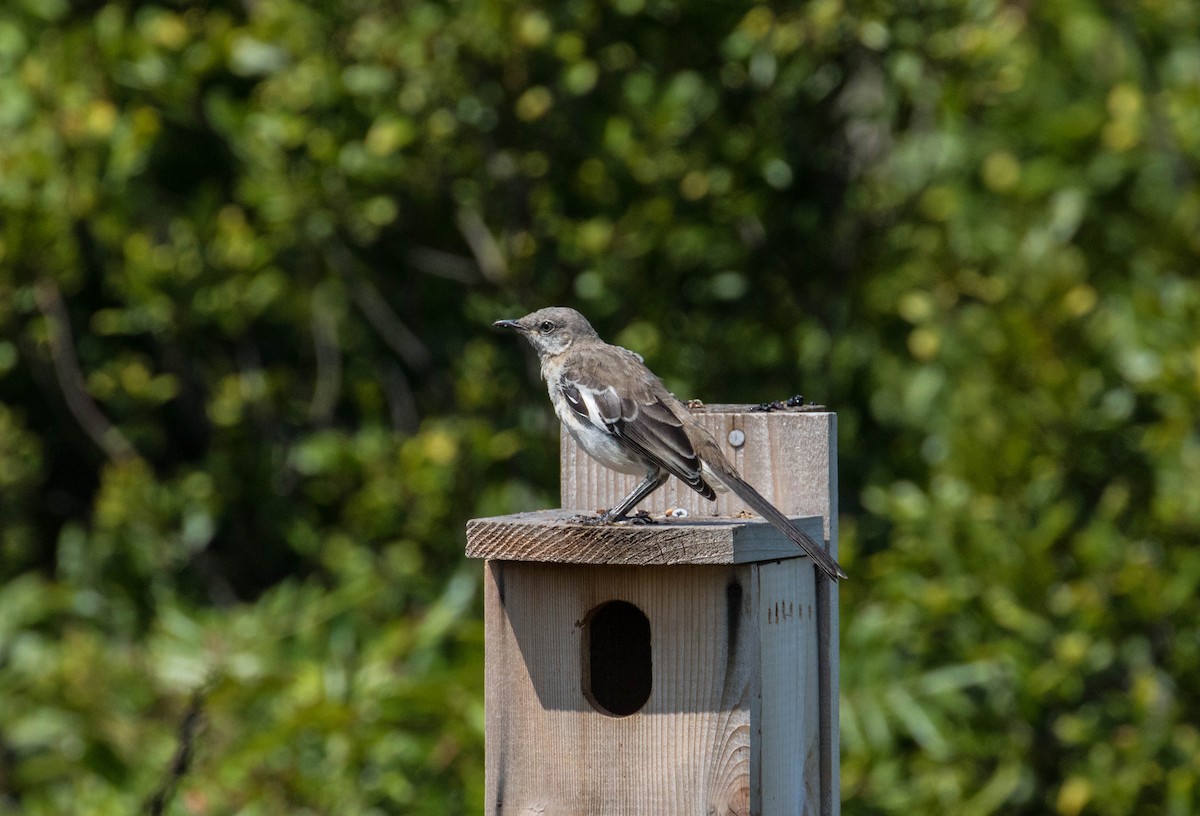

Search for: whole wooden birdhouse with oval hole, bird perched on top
xmin=467 ymin=406 xmax=839 ymax=816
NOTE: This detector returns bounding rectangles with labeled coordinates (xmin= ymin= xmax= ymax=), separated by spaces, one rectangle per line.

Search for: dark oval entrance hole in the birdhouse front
xmin=583 ymin=601 xmax=652 ymax=716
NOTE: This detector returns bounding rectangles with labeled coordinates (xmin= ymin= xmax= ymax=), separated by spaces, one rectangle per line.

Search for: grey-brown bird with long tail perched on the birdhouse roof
xmin=492 ymin=306 xmax=846 ymax=581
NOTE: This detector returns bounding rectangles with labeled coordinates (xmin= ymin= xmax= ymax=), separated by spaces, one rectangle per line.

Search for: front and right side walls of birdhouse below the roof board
xmin=485 ymin=554 xmax=821 ymax=816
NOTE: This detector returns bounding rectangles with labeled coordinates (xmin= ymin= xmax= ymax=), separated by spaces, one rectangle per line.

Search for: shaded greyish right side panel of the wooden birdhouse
xmin=750 ymin=560 xmax=824 ymax=816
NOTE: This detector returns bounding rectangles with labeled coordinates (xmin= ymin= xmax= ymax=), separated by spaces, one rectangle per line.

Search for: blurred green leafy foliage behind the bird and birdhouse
xmin=0 ymin=0 xmax=1200 ymax=816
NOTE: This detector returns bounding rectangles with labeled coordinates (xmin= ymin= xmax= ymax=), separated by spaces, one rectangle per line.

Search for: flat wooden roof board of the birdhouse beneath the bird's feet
xmin=467 ymin=510 xmax=822 ymax=564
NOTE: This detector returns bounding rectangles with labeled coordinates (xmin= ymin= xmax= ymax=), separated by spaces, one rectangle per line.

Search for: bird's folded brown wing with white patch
xmin=558 ymin=346 xmax=715 ymax=499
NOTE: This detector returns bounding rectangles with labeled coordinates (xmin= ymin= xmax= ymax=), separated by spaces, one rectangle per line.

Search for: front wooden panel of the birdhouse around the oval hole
xmin=485 ymin=559 xmax=753 ymax=816
